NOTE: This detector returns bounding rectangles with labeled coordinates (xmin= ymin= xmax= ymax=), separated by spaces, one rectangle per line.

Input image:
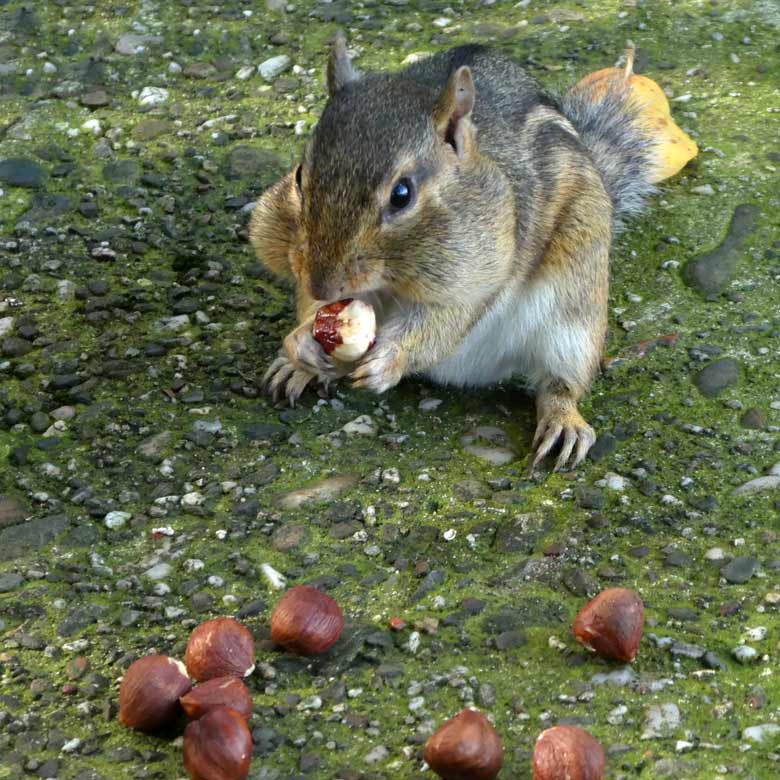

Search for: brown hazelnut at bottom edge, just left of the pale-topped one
xmin=423 ymin=709 xmax=504 ymax=780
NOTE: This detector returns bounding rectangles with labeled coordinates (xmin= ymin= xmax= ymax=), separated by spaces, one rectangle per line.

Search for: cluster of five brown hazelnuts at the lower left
xmin=119 ymin=585 xmax=344 ymax=780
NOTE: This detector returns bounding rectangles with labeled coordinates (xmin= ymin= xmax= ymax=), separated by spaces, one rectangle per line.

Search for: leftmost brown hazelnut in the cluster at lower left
xmin=119 ymin=655 xmax=192 ymax=731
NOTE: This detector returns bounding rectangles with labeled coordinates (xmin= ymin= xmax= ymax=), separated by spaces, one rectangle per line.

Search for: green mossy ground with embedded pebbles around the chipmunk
xmin=0 ymin=0 xmax=780 ymax=780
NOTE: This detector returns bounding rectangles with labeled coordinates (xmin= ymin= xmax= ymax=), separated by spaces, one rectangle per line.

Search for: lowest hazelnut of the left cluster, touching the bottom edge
xmin=184 ymin=707 xmax=252 ymax=780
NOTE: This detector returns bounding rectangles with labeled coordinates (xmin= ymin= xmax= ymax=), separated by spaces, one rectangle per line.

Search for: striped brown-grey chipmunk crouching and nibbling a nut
xmin=249 ymin=33 xmax=657 ymax=470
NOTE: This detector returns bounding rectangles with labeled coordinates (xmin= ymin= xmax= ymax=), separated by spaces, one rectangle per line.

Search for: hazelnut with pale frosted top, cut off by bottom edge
xmin=533 ymin=726 xmax=604 ymax=780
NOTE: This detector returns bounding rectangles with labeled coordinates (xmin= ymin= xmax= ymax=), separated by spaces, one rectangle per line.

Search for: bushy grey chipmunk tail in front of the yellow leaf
xmin=561 ymin=90 xmax=658 ymax=223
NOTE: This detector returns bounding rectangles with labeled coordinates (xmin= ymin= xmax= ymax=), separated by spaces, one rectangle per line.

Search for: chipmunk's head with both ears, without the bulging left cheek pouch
xmin=278 ymin=37 xmax=502 ymax=302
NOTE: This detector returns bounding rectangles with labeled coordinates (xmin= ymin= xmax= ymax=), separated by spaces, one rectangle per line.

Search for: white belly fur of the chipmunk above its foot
xmin=425 ymin=284 xmax=594 ymax=388
